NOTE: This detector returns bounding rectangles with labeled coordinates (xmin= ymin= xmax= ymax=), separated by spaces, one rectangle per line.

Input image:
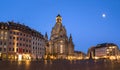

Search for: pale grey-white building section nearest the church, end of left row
xmin=31 ymin=32 xmax=46 ymax=59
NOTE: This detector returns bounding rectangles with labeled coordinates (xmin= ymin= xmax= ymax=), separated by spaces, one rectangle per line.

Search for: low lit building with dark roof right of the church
xmin=89 ymin=43 xmax=119 ymax=60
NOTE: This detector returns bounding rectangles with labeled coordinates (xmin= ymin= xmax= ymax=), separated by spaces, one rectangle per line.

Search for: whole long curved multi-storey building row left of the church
xmin=0 ymin=22 xmax=45 ymax=60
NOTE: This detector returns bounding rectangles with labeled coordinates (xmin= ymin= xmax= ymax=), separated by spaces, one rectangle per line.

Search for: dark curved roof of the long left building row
xmin=0 ymin=21 xmax=44 ymax=38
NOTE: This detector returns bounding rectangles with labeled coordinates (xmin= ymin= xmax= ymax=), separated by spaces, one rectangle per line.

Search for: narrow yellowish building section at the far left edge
xmin=0 ymin=22 xmax=9 ymax=59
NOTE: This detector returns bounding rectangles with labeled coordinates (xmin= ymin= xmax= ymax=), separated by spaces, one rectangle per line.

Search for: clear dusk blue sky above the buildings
xmin=0 ymin=0 xmax=120 ymax=53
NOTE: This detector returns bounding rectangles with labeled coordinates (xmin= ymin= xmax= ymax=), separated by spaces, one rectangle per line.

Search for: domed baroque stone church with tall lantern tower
xmin=47 ymin=14 xmax=74 ymax=59
